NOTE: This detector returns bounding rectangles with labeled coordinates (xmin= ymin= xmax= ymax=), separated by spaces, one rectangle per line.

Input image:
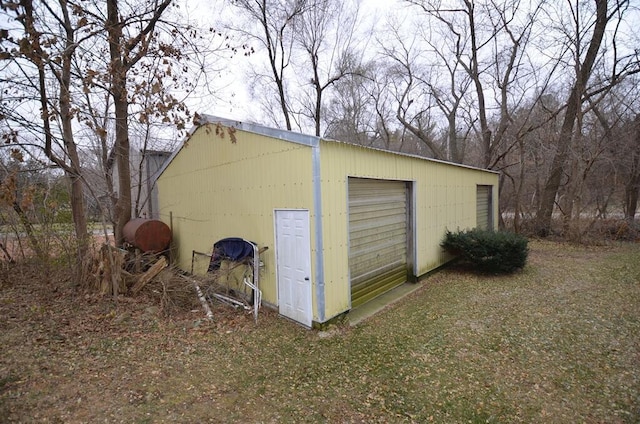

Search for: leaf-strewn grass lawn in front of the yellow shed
xmin=0 ymin=242 xmax=640 ymax=423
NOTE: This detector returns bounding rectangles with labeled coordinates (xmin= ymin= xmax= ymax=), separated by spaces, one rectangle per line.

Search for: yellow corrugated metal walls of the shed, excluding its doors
xmin=157 ymin=125 xmax=498 ymax=320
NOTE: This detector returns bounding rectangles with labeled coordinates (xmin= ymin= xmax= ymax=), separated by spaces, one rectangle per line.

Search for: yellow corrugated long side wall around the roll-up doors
xmin=320 ymin=141 xmax=498 ymax=318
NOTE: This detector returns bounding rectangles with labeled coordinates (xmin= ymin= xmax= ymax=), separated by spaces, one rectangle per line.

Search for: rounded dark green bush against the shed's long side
xmin=440 ymin=229 xmax=529 ymax=274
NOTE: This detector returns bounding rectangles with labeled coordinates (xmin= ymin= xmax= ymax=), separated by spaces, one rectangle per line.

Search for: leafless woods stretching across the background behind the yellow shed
xmin=0 ymin=0 xmax=640 ymax=278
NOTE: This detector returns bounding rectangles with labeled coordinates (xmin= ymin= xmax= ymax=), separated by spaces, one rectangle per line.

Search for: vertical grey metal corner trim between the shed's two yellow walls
xmin=311 ymin=139 xmax=326 ymax=322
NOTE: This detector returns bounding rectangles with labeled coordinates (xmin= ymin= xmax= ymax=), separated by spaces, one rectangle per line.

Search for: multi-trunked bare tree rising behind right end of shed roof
xmin=408 ymin=0 xmax=541 ymax=168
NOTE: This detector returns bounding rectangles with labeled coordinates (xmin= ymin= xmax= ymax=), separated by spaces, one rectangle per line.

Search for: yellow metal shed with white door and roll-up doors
xmin=157 ymin=116 xmax=498 ymax=326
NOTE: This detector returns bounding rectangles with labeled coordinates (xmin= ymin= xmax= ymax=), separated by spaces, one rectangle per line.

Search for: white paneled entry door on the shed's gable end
xmin=275 ymin=210 xmax=313 ymax=327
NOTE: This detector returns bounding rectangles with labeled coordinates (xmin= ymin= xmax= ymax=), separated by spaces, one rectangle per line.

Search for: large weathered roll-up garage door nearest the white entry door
xmin=349 ymin=178 xmax=409 ymax=307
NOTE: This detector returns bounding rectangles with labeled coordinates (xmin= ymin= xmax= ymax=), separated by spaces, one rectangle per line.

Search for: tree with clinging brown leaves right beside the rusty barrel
xmin=77 ymin=1 xmax=228 ymax=232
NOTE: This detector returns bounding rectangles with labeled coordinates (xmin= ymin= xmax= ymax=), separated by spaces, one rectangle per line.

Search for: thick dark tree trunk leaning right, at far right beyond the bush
xmin=536 ymin=0 xmax=608 ymax=237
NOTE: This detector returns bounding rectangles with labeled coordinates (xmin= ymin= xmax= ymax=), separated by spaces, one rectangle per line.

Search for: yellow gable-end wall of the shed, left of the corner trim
xmin=158 ymin=125 xmax=315 ymax=312
